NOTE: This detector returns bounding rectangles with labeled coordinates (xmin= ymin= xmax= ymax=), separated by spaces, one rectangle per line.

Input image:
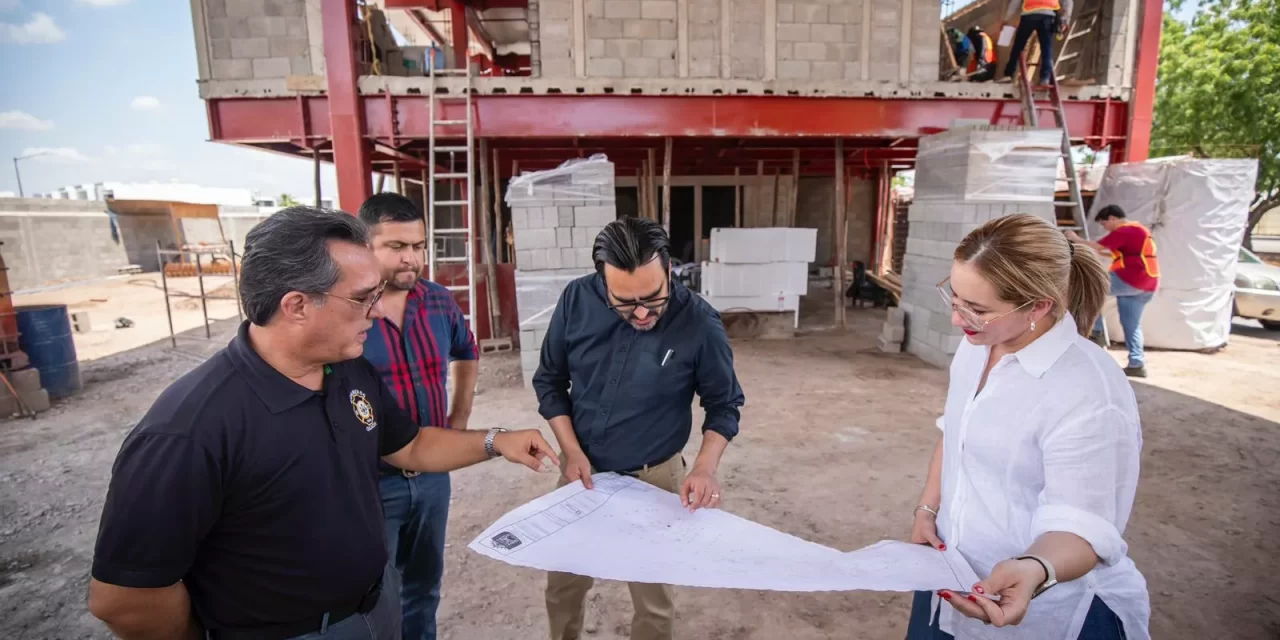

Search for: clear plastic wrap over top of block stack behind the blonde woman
xmin=915 ymin=127 xmax=1062 ymax=202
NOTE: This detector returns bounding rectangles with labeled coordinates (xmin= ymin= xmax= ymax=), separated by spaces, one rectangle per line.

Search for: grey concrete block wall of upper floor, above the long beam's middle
xmin=530 ymin=0 xmax=941 ymax=83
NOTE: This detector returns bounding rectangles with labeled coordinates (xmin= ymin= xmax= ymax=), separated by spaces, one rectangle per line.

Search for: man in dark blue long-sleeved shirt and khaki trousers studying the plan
xmin=534 ymin=218 xmax=744 ymax=640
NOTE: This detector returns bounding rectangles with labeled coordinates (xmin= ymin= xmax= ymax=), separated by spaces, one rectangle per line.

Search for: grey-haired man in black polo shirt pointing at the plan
xmin=90 ymin=207 xmax=553 ymax=640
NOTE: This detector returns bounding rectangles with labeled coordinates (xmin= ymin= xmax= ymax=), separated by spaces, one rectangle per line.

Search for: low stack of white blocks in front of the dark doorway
xmin=701 ymin=228 xmax=818 ymax=326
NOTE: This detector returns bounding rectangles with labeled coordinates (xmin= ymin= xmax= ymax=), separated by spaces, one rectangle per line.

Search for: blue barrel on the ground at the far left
xmin=14 ymin=305 xmax=83 ymax=398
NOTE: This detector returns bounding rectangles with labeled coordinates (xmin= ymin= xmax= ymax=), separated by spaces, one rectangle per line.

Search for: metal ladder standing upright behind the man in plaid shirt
xmin=426 ymin=60 xmax=477 ymax=335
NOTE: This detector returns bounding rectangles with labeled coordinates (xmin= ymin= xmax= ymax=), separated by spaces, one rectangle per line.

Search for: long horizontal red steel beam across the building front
xmin=207 ymin=92 xmax=1129 ymax=144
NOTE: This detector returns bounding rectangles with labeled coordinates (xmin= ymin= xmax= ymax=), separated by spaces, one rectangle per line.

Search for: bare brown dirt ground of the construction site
xmin=0 ymin=310 xmax=1280 ymax=640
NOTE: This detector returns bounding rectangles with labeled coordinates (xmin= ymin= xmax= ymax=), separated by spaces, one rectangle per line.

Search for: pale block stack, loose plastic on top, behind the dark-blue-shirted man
xmin=506 ymin=156 xmax=617 ymax=387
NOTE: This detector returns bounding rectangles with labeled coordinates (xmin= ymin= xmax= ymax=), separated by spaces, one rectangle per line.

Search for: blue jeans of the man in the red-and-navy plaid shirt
xmin=378 ymin=474 xmax=451 ymax=640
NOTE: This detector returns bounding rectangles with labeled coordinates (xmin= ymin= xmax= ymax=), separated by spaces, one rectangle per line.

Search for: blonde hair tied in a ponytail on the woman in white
xmin=955 ymin=214 xmax=1110 ymax=335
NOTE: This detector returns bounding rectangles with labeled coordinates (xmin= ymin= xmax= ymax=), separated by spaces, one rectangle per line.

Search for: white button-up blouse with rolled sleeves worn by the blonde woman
xmin=933 ymin=315 xmax=1151 ymax=640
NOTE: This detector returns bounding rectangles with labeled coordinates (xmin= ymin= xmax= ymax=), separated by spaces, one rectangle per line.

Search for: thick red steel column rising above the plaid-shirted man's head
xmin=320 ymin=0 xmax=374 ymax=214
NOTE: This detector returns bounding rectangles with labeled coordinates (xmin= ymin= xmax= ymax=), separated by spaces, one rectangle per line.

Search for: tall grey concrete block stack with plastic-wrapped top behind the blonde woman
xmin=900 ymin=127 xmax=1062 ymax=366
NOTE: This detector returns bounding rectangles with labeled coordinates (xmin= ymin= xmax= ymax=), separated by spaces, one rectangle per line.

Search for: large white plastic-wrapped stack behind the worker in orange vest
xmin=1089 ymin=157 xmax=1258 ymax=351
